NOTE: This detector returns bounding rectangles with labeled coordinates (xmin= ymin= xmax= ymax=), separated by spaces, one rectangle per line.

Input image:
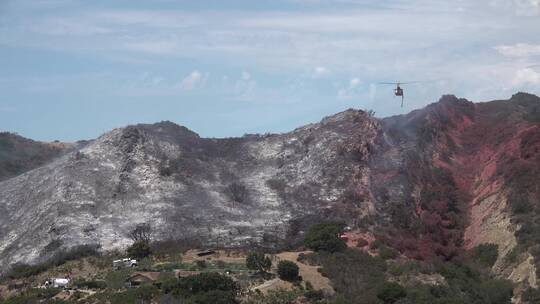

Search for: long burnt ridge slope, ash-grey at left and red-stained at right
xmin=0 ymin=93 xmax=540 ymax=287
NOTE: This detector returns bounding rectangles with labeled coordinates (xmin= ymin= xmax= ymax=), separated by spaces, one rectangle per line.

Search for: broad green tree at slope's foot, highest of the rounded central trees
xmin=304 ymin=221 xmax=347 ymax=252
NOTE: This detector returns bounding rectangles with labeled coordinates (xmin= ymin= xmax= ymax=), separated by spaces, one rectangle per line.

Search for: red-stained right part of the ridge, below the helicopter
xmin=371 ymin=93 xmax=540 ymax=268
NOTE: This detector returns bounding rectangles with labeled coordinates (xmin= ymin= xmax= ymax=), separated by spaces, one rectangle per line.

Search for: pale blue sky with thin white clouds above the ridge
xmin=0 ymin=0 xmax=540 ymax=141
